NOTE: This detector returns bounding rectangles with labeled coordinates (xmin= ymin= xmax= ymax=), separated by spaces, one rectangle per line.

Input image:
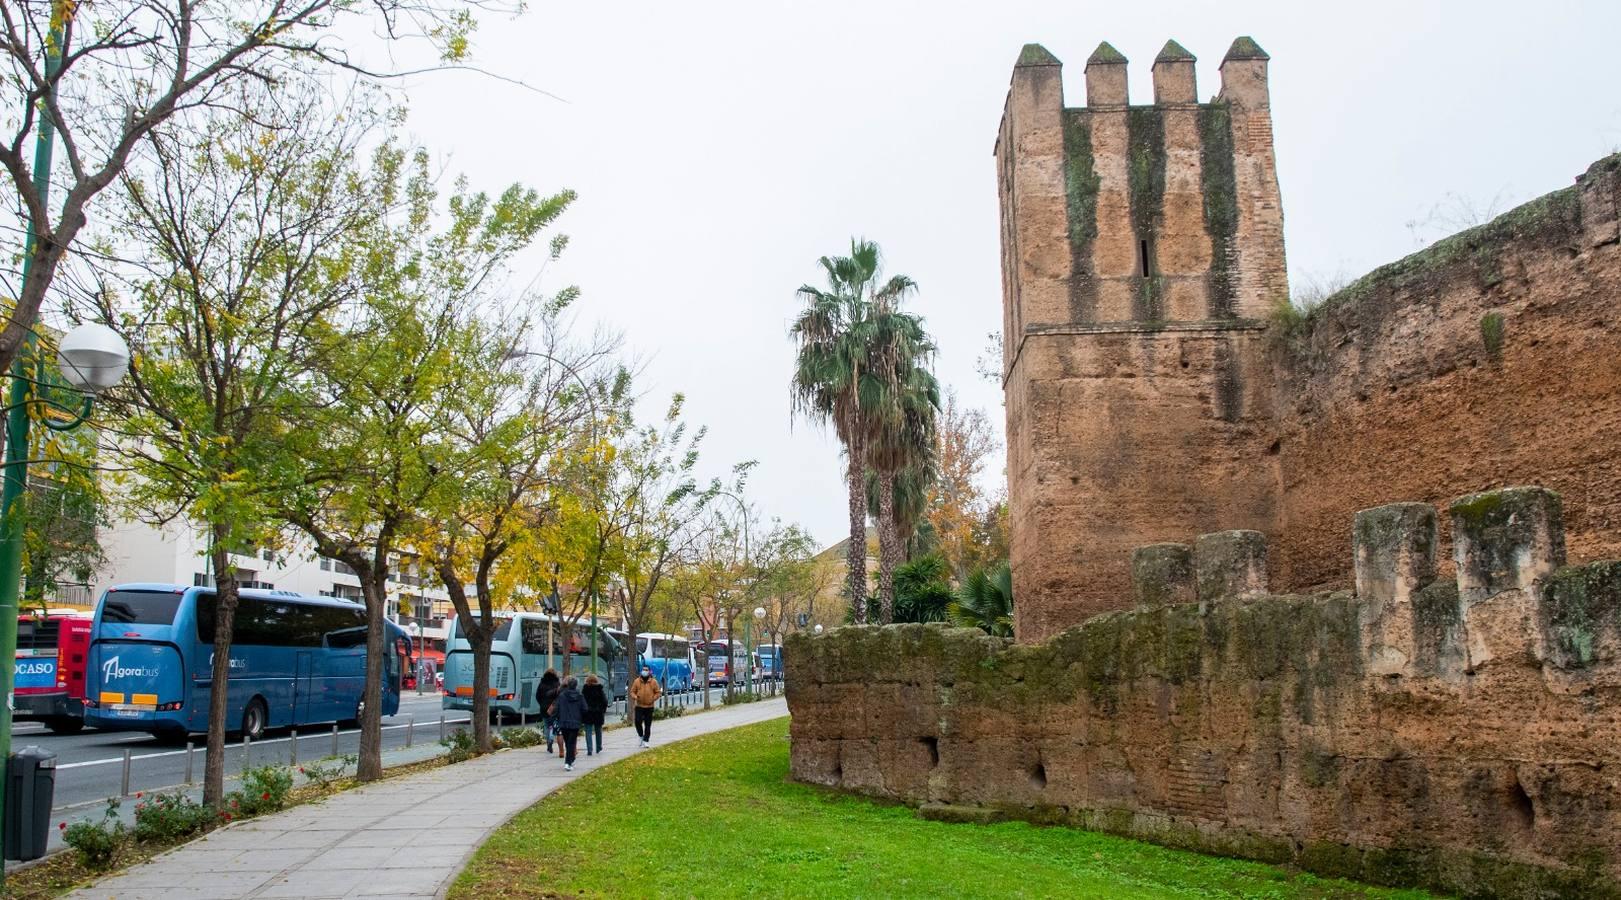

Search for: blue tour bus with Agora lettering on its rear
xmin=84 ymin=584 xmax=410 ymax=738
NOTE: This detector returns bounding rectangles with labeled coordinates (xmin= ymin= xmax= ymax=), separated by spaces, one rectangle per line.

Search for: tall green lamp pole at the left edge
xmin=0 ymin=14 xmax=62 ymax=877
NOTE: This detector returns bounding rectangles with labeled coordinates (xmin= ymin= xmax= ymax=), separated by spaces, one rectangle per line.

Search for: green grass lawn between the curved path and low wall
xmin=451 ymin=718 xmax=1426 ymax=898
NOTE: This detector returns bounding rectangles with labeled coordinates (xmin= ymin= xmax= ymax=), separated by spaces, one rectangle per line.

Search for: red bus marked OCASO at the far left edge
xmin=11 ymin=613 xmax=91 ymax=735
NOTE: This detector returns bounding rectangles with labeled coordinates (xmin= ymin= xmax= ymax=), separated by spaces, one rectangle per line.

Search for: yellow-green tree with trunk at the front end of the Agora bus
xmin=280 ymin=153 xmax=574 ymax=780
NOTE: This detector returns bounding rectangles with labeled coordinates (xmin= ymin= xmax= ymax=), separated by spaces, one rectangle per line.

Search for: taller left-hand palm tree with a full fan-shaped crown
xmin=789 ymin=238 xmax=917 ymax=624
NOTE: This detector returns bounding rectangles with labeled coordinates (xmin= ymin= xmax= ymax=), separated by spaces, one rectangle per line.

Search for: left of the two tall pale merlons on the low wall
xmin=1352 ymin=503 xmax=1436 ymax=675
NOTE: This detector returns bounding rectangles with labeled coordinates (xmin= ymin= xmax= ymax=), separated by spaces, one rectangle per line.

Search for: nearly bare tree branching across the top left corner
xmin=0 ymin=0 xmax=499 ymax=370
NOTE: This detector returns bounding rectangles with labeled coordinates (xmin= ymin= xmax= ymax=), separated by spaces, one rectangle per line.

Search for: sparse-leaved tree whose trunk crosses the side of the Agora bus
xmin=84 ymin=88 xmax=376 ymax=806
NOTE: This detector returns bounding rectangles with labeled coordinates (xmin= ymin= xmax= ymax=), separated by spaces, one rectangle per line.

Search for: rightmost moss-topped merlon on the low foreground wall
xmin=1451 ymin=486 xmax=1564 ymax=608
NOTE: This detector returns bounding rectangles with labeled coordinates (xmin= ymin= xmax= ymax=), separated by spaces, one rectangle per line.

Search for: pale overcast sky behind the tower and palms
xmin=385 ymin=0 xmax=1621 ymax=543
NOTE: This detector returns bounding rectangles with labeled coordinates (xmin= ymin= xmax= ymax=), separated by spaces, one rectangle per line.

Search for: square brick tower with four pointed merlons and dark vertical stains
xmin=995 ymin=37 xmax=1289 ymax=641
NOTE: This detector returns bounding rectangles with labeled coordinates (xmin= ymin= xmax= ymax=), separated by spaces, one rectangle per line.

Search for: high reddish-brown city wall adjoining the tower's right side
xmin=1268 ymin=156 xmax=1621 ymax=600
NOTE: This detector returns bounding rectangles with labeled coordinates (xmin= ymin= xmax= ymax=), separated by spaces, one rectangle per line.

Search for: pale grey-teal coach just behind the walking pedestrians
xmin=441 ymin=613 xmax=624 ymax=718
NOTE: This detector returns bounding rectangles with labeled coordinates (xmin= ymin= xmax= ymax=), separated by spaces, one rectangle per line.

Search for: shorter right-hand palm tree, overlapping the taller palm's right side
xmin=867 ymin=363 xmax=940 ymax=624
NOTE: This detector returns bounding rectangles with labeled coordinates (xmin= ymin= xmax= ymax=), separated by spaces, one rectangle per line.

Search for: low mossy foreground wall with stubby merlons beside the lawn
xmin=785 ymin=488 xmax=1621 ymax=897
